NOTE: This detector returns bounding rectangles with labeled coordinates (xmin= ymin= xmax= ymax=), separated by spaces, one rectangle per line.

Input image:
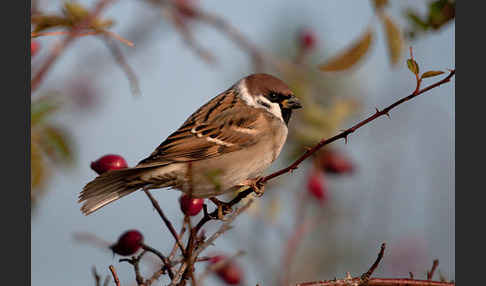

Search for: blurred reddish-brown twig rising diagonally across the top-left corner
xmin=30 ymin=0 xmax=114 ymax=93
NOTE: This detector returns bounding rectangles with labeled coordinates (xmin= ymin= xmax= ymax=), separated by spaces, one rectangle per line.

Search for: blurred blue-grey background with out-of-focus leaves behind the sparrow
xmin=31 ymin=0 xmax=455 ymax=285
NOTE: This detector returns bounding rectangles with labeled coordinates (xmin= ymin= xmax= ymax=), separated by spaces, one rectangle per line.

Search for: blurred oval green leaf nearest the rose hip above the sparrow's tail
xmin=41 ymin=125 xmax=73 ymax=163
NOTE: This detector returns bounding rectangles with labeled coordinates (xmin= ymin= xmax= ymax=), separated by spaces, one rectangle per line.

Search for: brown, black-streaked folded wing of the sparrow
xmin=137 ymin=90 xmax=266 ymax=168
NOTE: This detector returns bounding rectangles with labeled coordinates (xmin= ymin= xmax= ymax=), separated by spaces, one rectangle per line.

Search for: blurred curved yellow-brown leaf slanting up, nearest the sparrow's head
xmin=319 ymin=29 xmax=373 ymax=72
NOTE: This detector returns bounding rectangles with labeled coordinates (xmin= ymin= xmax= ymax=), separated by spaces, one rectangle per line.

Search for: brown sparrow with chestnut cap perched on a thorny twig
xmin=79 ymin=74 xmax=302 ymax=215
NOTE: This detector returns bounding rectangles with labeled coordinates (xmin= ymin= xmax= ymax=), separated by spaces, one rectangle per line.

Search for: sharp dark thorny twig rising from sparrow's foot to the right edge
xmin=260 ymin=70 xmax=456 ymax=184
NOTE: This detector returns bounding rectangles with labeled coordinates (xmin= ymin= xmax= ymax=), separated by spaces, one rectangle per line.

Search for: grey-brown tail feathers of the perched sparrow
xmin=78 ymin=168 xmax=150 ymax=215
